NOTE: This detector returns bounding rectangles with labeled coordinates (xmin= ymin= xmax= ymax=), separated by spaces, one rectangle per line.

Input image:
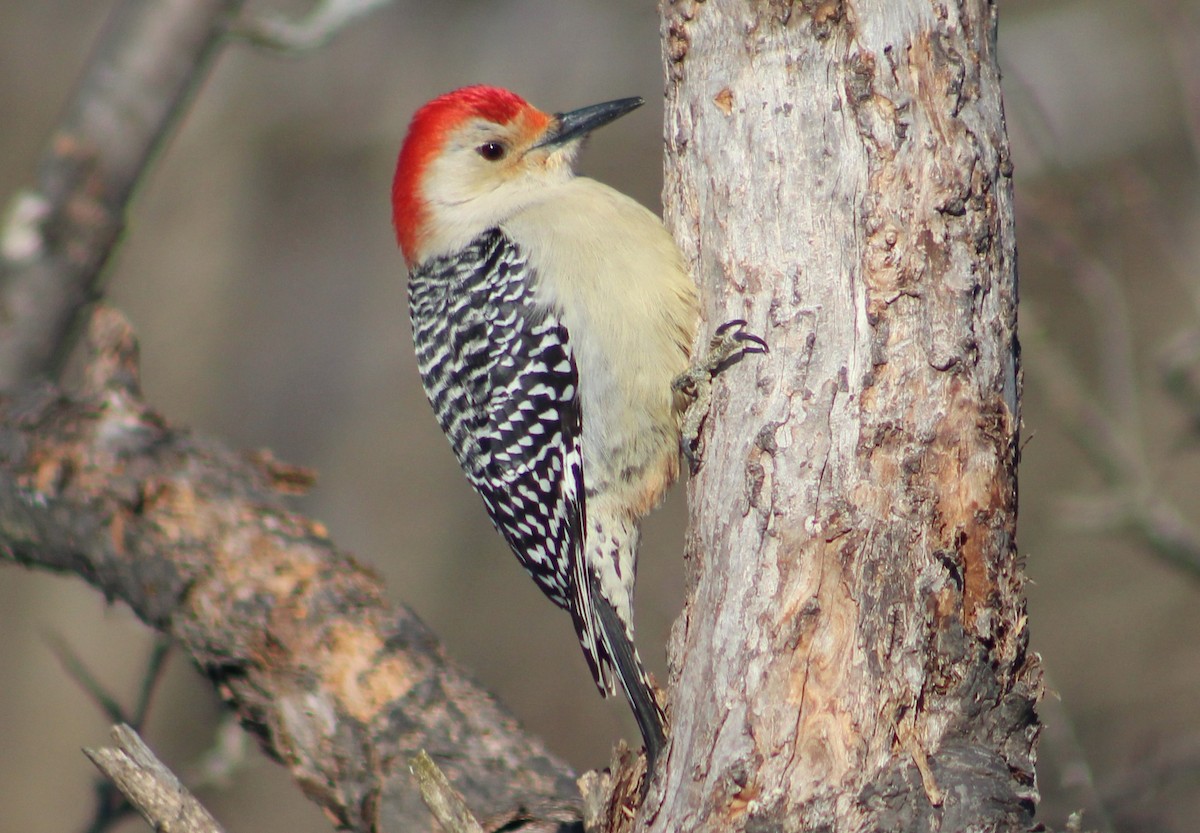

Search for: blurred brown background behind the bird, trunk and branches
xmin=0 ymin=0 xmax=1200 ymax=833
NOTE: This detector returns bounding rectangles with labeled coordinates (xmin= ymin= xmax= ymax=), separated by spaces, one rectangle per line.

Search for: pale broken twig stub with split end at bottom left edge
xmin=83 ymin=724 xmax=223 ymax=833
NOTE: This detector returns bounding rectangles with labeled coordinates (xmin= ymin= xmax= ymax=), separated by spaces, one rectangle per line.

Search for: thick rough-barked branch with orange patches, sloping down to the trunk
xmin=0 ymin=308 xmax=580 ymax=833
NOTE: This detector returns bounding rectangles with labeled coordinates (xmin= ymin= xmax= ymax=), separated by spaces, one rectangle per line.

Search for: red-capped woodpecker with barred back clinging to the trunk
xmin=392 ymin=86 xmax=761 ymax=767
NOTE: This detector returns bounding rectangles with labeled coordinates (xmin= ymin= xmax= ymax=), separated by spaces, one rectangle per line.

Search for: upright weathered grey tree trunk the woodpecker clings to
xmin=642 ymin=0 xmax=1040 ymax=831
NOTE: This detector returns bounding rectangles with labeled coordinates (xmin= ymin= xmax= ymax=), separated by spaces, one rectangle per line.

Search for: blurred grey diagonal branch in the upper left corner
xmin=0 ymin=0 xmax=241 ymax=389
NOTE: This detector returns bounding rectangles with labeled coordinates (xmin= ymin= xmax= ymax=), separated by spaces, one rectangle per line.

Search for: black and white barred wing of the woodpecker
xmin=409 ymin=230 xmax=584 ymax=616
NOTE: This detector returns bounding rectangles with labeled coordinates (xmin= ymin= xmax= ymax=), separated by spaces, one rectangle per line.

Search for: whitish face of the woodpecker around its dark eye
xmin=421 ymin=115 xmax=580 ymax=256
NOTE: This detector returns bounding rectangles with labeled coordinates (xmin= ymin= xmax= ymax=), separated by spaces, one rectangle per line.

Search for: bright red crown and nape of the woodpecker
xmin=391 ymin=84 xmax=529 ymax=265
